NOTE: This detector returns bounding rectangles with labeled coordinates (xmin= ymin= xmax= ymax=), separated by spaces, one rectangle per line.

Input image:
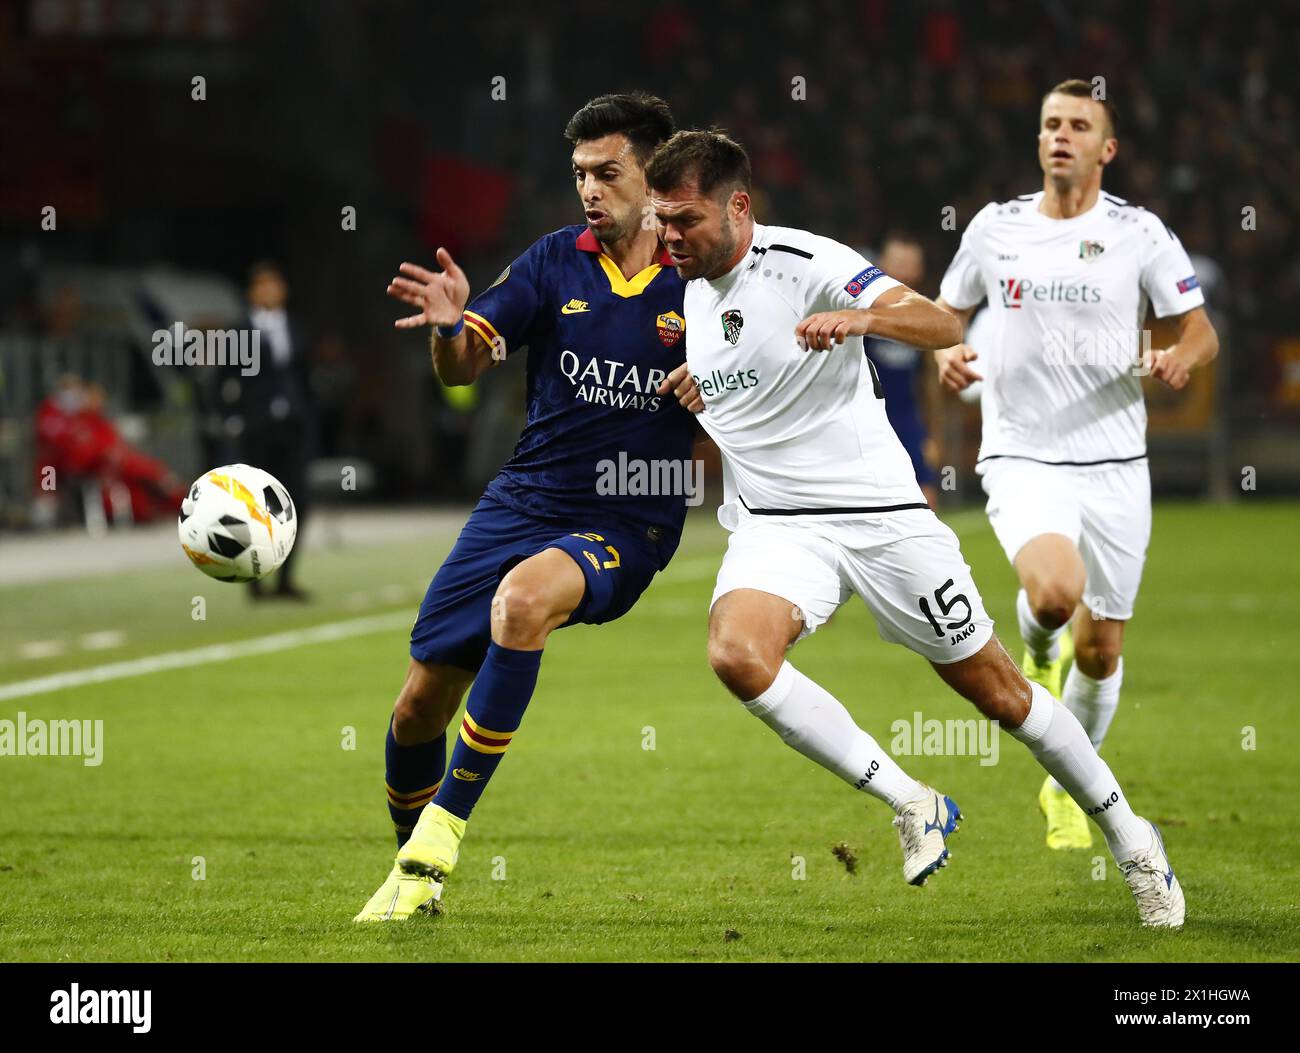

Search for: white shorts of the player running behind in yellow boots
xmin=976 ymin=458 xmax=1151 ymax=621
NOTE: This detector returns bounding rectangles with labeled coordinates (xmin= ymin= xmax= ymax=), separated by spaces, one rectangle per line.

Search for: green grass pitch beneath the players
xmin=0 ymin=502 xmax=1300 ymax=961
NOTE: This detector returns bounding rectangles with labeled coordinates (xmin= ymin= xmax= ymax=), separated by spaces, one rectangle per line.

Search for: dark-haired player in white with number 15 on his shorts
xmin=646 ymin=131 xmax=1184 ymax=927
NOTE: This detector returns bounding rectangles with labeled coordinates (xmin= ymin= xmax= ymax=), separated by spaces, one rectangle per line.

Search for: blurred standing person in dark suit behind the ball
xmin=236 ymin=260 xmax=316 ymax=599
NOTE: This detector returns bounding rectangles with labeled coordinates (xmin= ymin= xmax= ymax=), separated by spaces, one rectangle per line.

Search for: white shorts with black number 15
xmin=710 ymin=508 xmax=993 ymax=664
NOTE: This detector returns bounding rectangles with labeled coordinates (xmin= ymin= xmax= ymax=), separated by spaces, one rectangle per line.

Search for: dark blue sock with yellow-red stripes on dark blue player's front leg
xmin=433 ymin=644 xmax=542 ymax=819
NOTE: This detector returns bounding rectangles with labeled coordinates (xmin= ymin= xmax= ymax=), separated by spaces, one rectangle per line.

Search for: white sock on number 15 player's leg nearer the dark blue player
xmin=744 ymin=662 xmax=926 ymax=811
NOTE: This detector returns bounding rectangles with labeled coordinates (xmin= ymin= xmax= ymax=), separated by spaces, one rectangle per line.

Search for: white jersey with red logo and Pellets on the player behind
xmin=939 ymin=191 xmax=1205 ymax=464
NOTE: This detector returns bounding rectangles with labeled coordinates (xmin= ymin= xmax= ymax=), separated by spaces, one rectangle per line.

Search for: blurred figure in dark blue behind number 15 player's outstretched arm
xmin=865 ymin=231 xmax=939 ymax=508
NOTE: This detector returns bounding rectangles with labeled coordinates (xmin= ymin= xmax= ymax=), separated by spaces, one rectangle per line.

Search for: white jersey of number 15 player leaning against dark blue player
xmin=685 ymin=224 xmax=926 ymax=529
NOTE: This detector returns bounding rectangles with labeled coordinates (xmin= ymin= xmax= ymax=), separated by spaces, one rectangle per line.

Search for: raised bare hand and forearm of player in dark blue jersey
xmin=387 ymin=248 xmax=498 ymax=387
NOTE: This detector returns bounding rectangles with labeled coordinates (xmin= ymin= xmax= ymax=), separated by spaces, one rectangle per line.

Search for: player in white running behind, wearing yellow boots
xmin=935 ymin=81 xmax=1218 ymax=849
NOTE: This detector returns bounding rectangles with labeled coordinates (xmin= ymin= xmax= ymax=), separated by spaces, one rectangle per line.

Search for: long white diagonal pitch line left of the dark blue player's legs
xmin=0 ymin=614 xmax=411 ymax=702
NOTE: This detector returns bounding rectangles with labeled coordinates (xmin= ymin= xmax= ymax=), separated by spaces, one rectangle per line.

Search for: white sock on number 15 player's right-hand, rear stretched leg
xmin=1009 ymin=683 xmax=1151 ymax=859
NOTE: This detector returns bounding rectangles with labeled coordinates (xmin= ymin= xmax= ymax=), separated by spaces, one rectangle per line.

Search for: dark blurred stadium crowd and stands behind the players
xmin=0 ymin=0 xmax=1300 ymax=528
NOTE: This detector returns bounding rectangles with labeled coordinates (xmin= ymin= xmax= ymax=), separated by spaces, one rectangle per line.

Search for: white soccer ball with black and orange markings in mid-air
xmin=177 ymin=464 xmax=298 ymax=581
